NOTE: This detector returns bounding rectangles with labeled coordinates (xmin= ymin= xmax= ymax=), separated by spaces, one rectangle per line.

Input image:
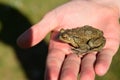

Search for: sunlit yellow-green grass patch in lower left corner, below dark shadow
xmin=0 ymin=42 xmax=27 ymax=80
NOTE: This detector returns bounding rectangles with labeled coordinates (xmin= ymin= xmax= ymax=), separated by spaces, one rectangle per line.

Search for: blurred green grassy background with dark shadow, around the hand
xmin=0 ymin=0 xmax=120 ymax=80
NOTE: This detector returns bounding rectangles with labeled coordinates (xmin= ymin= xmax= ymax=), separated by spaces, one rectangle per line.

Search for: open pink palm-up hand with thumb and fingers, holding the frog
xmin=17 ymin=0 xmax=120 ymax=80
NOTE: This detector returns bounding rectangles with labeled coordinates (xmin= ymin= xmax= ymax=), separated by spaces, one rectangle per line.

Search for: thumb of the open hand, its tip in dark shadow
xmin=17 ymin=11 xmax=58 ymax=48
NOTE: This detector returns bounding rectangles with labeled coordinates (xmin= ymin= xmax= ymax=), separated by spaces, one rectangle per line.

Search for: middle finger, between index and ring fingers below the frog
xmin=60 ymin=54 xmax=80 ymax=80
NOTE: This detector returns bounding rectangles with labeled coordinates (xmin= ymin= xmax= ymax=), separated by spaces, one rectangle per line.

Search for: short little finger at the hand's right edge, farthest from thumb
xmin=95 ymin=49 xmax=119 ymax=76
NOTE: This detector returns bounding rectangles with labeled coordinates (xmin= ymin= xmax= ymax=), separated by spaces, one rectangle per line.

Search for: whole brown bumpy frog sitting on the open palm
xmin=58 ymin=25 xmax=106 ymax=56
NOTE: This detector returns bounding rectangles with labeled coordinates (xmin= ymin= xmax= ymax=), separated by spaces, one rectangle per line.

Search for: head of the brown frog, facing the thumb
xmin=59 ymin=29 xmax=76 ymax=46
